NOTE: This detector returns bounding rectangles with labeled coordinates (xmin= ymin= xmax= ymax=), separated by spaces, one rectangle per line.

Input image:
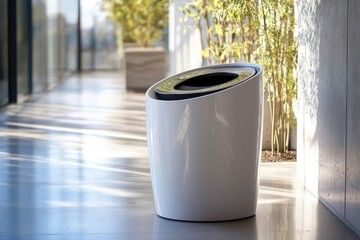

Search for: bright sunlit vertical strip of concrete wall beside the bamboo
xmin=296 ymin=0 xmax=321 ymax=195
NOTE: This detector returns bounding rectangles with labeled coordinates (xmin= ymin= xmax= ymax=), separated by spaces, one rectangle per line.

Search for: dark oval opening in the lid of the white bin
xmin=174 ymin=72 xmax=239 ymax=90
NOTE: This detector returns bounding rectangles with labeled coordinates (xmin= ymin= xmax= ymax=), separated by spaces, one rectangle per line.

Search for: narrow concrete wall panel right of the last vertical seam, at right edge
xmin=345 ymin=0 xmax=360 ymax=230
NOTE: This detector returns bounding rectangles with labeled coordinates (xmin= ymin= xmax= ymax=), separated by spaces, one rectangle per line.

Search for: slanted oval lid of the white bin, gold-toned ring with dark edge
xmin=154 ymin=64 xmax=256 ymax=100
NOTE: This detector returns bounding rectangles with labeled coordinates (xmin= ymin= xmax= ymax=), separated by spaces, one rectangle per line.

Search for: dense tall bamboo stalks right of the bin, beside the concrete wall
xmin=259 ymin=0 xmax=297 ymax=153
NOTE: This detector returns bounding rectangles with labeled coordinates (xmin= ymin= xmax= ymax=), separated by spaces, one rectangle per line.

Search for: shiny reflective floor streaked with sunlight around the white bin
xmin=0 ymin=73 xmax=356 ymax=240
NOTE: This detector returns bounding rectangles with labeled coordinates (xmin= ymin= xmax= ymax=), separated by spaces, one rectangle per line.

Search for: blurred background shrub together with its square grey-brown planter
xmin=102 ymin=0 xmax=168 ymax=90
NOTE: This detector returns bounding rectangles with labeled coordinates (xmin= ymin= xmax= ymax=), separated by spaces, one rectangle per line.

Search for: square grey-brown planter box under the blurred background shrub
xmin=124 ymin=47 xmax=166 ymax=91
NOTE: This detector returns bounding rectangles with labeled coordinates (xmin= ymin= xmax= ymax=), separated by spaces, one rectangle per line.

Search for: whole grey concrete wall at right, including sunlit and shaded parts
xmin=297 ymin=0 xmax=360 ymax=234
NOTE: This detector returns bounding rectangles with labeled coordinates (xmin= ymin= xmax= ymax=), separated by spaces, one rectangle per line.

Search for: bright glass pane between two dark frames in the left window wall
xmin=32 ymin=0 xmax=79 ymax=91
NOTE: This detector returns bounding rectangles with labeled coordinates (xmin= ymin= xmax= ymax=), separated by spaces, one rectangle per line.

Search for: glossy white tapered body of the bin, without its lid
xmin=146 ymin=64 xmax=263 ymax=221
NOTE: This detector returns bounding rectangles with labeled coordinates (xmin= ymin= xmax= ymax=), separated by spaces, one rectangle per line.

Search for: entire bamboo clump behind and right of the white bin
xmin=180 ymin=0 xmax=297 ymax=153
